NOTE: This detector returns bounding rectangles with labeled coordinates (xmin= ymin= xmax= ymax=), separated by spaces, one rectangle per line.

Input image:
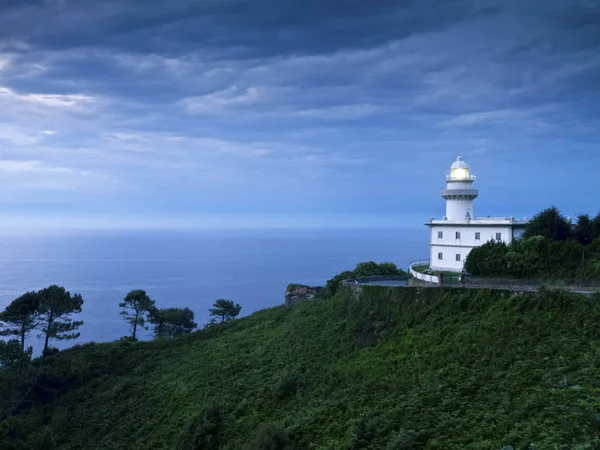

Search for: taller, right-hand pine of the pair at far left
xmin=38 ymin=284 xmax=83 ymax=355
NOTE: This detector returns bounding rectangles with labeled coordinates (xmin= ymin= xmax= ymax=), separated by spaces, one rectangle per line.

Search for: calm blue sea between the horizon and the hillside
xmin=0 ymin=228 xmax=428 ymax=349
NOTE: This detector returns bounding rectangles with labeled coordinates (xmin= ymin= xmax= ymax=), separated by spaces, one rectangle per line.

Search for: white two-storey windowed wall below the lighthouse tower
xmin=430 ymin=224 xmax=513 ymax=272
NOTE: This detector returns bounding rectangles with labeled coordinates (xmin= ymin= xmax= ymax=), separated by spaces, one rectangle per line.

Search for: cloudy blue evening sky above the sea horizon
xmin=0 ymin=0 xmax=600 ymax=228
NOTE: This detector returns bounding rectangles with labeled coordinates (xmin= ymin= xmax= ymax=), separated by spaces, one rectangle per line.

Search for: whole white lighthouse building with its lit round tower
xmin=427 ymin=156 xmax=527 ymax=272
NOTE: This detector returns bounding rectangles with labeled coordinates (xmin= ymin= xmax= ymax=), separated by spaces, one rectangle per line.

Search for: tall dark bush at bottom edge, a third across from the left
xmin=176 ymin=405 xmax=222 ymax=450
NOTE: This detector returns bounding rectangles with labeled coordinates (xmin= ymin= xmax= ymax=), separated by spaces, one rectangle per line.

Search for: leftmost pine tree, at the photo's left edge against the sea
xmin=0 ymin=292 xmax=39 ymax=352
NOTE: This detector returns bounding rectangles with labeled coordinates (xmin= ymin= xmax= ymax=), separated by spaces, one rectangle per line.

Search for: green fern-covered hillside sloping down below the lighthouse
xmin=0 ymin=286 xmax=600 ymax=450
